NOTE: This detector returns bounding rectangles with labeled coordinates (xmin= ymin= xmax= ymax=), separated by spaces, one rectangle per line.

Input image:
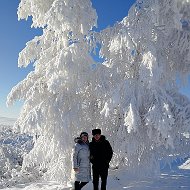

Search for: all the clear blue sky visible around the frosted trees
xmin=0 ymin=0 xmax=190 ymax=118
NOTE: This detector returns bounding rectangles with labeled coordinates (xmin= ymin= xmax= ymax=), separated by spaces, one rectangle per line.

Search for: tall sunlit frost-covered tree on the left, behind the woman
xmin=8 ymin=0 xmax=97 ymax=183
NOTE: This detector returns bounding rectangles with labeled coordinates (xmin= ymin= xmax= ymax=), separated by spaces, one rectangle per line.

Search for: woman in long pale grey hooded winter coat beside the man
xmin=73 ymin=132 xmax=91 ymax=190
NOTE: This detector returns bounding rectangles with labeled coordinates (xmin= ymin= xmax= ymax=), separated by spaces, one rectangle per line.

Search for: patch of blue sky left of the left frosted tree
xmin=0 ymin=0 xmax=40 ymax=117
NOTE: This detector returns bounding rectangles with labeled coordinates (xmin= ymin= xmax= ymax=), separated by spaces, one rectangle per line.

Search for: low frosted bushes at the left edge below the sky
xmin=0 ymin=125 xmax=33 ymax=187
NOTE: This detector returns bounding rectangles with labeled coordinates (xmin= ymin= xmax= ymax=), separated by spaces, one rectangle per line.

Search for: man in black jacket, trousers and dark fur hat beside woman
xmin=89 ymin=129 xmax=113 ymax=190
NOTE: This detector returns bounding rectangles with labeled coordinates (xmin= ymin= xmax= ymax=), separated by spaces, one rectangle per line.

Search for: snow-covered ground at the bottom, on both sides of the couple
xmin=3 ymin=166 xmax=190 ymax=190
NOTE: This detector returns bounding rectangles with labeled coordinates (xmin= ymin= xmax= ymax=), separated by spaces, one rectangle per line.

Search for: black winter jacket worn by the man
xmin=89 ymin=135 xmax=113 ymax=168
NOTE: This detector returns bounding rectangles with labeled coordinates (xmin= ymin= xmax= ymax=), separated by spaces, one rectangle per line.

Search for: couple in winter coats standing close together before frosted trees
xmin=73 ymin=129 xmax=113 ymax=190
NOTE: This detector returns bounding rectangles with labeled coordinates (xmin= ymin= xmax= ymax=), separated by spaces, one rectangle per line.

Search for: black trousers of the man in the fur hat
xmin=92 ymin=166 xmax=108 ymax=190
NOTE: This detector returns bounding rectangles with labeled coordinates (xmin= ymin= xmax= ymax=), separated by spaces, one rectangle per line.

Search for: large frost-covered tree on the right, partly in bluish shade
xmin=99 ymin=0 xmax=190 ymax=173
